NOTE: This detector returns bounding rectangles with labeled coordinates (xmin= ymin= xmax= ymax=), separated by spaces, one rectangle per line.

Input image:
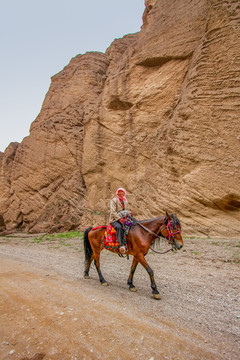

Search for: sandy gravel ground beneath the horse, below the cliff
xmin=0 ymin=234 xmax=240 ymax=360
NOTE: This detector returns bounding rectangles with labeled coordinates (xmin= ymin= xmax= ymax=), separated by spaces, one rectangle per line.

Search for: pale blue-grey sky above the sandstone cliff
xmin=0 ymin=0 xmax=145 ymax=152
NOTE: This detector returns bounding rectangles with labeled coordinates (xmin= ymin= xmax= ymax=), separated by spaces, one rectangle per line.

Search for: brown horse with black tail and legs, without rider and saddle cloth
xmin=84 ymin=213 xmax=183 ymax=299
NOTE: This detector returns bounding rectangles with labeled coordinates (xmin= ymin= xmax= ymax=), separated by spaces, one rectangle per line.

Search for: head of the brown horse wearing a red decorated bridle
xmin=160 ymin=212 xmax=183 ymax=250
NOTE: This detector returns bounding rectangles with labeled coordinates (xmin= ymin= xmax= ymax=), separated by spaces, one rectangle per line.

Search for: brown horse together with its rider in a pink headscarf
xmin=84 ymin=188 xmax=183 ymax=300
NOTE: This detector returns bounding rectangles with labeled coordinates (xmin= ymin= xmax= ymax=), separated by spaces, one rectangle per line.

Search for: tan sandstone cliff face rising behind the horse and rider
xmin=0 ymin=0 xmax=240 ymax=237
